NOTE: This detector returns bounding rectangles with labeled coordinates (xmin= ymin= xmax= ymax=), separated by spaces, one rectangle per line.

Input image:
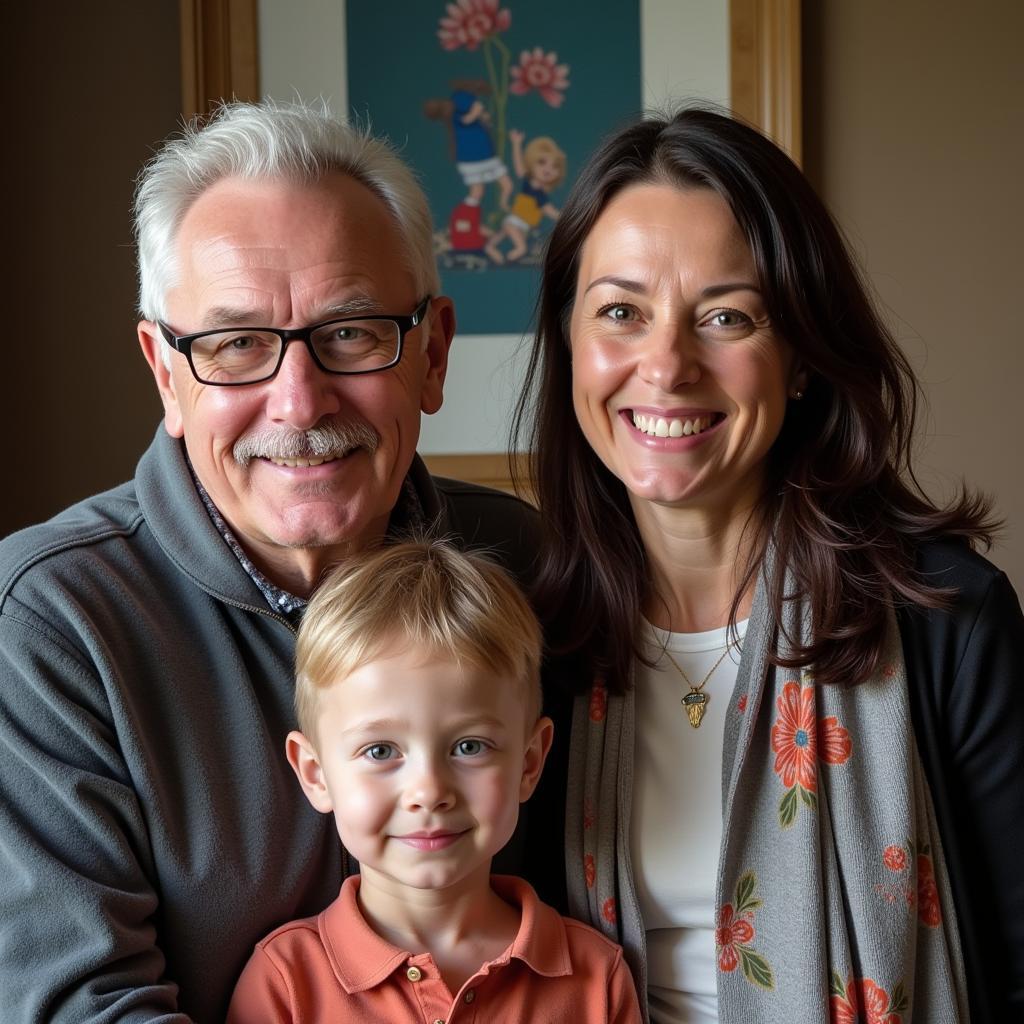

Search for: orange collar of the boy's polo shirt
xmin=316 ymin=874 xmax=572 ymax=994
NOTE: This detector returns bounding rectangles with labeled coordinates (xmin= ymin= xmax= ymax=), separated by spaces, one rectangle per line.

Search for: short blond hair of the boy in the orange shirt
xmin=295 ymin=541 xmax=542 ymax=737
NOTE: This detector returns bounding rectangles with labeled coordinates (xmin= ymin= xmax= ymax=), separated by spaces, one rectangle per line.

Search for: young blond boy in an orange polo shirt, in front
xmin=227 ymin=543 xmax=641 ymax=1024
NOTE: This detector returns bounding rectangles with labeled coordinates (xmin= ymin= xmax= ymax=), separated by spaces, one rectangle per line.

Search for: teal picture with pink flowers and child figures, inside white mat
xmin=345 ymin=0 xmax=642 ymax=336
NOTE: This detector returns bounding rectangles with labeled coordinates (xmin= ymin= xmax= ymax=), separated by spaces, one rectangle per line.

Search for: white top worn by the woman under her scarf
xmin=630 ymin=620 xmax=746 ymax=1024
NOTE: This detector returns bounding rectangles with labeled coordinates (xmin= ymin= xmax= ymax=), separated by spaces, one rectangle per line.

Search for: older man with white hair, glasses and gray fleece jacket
xmin=0 ymin=104 xmax=534 ymax=1024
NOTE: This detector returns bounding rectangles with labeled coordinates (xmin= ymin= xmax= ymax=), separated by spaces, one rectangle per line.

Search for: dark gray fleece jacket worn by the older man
xmin=0 ymin=429 xmax=536 ymax=1024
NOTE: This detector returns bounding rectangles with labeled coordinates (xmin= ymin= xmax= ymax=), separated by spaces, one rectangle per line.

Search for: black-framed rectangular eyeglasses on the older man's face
xmin=157 ymin=295 xmax=431 ymax=387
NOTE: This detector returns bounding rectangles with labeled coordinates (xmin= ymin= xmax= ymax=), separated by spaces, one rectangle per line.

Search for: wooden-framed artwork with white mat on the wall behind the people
xmin=181 ymin=0 xmax=801 ymax=486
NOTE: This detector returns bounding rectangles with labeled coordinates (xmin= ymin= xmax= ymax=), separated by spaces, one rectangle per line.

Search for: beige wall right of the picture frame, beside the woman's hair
xmin=803 ymin=0 xmax=1024 ymax=593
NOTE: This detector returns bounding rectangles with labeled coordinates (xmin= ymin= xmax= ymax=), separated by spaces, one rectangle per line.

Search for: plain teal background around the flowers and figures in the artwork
xmin=346 ymin=0 xmax=641 ymax=334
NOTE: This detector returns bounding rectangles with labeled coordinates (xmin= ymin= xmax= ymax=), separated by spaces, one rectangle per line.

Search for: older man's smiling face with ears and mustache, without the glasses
xmin=139 ymin=173 xmax=454 ymax=590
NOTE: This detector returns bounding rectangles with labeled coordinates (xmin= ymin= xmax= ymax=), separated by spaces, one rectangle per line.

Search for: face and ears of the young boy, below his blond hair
xmin=287 ymin=647 xmax=552 ymax=892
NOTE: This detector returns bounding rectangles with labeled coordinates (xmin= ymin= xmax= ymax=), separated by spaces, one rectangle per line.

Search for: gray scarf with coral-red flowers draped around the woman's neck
xmin=566 ymin=561 xmax=969 ymax=1024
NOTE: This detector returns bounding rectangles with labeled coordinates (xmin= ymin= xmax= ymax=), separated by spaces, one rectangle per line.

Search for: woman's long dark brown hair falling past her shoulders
xmin=512 ymin=109 xmax=995 ymax=690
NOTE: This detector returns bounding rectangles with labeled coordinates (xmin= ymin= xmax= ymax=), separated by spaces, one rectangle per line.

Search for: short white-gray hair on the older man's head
xmin=134 ymin=99 xmax=440 ymax=323
